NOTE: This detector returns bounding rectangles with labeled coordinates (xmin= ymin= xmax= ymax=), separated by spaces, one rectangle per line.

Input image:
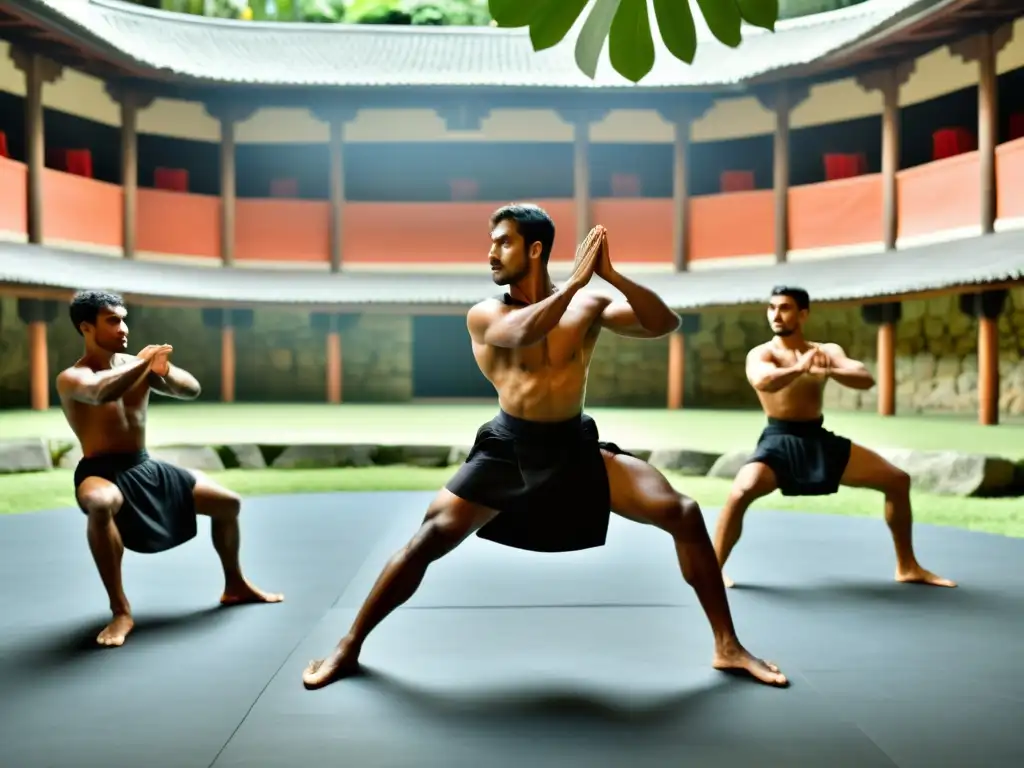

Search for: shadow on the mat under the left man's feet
xmin=2 ymin=605 xmax=238 ymax=673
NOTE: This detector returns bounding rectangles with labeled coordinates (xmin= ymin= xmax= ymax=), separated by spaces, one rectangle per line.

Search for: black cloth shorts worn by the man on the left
xmin=75 ymin=451 xmax=197 ymax=554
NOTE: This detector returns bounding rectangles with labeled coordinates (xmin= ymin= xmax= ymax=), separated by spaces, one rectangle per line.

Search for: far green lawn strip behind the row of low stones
xmin=0 ymin=400 xmax=1024 ymax=460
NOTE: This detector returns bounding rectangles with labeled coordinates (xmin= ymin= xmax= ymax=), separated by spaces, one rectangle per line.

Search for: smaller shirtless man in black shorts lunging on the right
xmin=715 ymin=286 xmax=956 ymax=587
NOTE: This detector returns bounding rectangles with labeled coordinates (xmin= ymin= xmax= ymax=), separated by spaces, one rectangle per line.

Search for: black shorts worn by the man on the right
xmin=748 ymin=418 xmax=852 ymax=496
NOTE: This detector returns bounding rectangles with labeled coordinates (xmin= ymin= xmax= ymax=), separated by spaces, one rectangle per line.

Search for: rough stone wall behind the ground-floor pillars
xmin=0 ymin=289 xmax=1024 ymax=415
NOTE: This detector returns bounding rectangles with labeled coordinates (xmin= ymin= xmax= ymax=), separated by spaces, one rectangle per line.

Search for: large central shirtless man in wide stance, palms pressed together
xmin=302 ymin=205 xmax=786 ymax=688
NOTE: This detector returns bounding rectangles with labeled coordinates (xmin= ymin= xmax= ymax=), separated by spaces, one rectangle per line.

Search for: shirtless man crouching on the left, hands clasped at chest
xmin=57 ymin=291 xmax=284 ymax=646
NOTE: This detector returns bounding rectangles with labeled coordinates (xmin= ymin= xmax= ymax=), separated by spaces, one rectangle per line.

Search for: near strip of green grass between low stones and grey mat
xmin=0 ymin=466 xmax=1024 ymax=538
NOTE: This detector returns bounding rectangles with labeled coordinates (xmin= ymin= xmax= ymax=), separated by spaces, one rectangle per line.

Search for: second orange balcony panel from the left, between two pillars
xmin=43 ymin=168 xmax=124 ymax=248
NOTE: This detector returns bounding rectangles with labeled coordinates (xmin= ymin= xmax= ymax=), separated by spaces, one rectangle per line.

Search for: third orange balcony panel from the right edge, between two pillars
xmin=790 ymin=173 xmax=883 ymax=251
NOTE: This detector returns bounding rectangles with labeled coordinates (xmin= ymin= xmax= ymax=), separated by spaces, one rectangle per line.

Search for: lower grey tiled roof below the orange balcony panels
xmin=0 ymin=230 xmax=1024 ymax=311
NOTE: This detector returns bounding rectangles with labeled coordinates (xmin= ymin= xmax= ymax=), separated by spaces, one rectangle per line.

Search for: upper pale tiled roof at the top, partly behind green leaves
xmin=14 ymin=0 xmax=949 ymax=89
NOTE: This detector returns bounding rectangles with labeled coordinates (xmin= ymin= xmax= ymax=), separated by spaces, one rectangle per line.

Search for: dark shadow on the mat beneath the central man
xmin=344 ymin=668 xmax=745 ymax=728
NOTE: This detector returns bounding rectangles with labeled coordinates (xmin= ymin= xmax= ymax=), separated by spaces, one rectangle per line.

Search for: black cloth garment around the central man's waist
xmin=445 ymin=411 xmax=630 ymax=552
